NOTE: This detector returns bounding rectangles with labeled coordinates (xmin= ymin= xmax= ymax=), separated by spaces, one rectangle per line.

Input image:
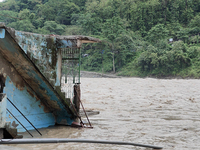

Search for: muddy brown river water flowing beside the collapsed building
xmin=0 ymin=78 xmax=200 ymax=150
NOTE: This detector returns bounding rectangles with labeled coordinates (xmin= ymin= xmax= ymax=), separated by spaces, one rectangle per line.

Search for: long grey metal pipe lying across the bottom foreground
xmin=0 ymin=138 xmax=163 ymax=149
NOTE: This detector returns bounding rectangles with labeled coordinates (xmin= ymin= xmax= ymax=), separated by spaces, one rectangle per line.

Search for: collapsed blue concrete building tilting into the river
xmin=0 ymin=23 xmax=100 ymax=138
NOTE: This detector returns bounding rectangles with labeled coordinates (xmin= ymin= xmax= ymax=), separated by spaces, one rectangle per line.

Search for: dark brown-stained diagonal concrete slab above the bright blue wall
xmin=0 ymin=25 xmax=73 ymax=124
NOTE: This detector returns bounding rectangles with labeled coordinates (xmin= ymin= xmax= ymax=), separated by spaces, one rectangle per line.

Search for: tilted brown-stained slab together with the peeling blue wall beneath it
xmin=0 ymin=25 xmax=73 ymax=132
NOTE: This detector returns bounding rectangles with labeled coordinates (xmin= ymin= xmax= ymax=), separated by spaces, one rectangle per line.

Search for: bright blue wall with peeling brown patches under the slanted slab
xmin=0 ymin=45 xmax=55 ymax=131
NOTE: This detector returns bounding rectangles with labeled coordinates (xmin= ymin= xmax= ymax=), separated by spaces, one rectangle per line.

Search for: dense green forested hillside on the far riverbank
xmin=0 ymin=0 xmax=200 ymax=78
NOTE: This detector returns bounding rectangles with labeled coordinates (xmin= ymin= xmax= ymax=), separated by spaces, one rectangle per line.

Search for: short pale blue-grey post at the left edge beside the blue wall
xmin=0 ymin=93 xmax=7 ymax=139
